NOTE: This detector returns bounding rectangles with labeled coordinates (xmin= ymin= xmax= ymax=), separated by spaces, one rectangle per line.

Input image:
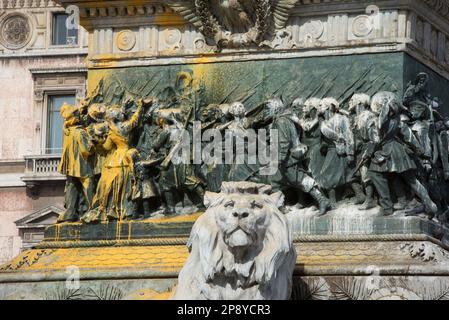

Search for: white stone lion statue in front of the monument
xmin=173 ymin=182 xmax=296 ymax=300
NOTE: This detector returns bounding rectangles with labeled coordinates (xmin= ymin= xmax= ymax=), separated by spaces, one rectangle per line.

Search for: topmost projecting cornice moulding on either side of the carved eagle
xmin=52 ymin=0 xmax=449 ymax=43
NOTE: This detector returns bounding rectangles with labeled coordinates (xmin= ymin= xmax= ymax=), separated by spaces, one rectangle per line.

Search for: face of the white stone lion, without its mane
xmin=215 ymin=195 xmax=273 ymax=249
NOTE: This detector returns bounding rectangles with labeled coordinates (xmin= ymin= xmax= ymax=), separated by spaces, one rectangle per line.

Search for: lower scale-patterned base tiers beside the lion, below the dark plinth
xmin=0 ymin=231 xmax=449 ymax=300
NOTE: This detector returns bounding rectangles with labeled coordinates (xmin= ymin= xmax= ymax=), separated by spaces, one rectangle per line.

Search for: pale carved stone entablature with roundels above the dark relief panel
xmin=53 ymin=0 xmax=449 ymax=78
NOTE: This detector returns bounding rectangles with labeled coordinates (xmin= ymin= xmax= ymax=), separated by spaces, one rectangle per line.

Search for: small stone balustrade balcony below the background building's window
xmin=22 ymin=154 xmax=65 ymax=186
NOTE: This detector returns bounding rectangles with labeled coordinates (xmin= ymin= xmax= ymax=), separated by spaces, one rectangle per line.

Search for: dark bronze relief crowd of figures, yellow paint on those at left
xmin=59 ymin=72 xmax=449 ymax=223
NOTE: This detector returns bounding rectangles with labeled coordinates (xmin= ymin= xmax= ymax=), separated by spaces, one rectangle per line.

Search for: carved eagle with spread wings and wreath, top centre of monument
xmin=167 ymin=0 xmax=298 ymax=49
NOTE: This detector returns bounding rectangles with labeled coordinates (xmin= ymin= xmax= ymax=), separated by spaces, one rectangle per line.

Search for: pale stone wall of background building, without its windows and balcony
xmin=0 ymin=0 xmax=87 ymax=263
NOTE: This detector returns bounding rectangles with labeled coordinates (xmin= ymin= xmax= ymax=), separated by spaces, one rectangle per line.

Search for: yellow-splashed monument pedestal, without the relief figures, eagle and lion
xmin=0 ymin=0 xmax=449 ymax=299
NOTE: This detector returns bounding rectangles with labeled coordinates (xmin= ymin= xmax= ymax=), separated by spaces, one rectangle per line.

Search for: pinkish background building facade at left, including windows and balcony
xmin=0 ymin=0 xmax=88 ymax=264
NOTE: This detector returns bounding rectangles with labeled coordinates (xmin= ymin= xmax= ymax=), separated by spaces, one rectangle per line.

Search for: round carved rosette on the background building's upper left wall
xmin=0 ymin=14 xmax=31 ymax=49
